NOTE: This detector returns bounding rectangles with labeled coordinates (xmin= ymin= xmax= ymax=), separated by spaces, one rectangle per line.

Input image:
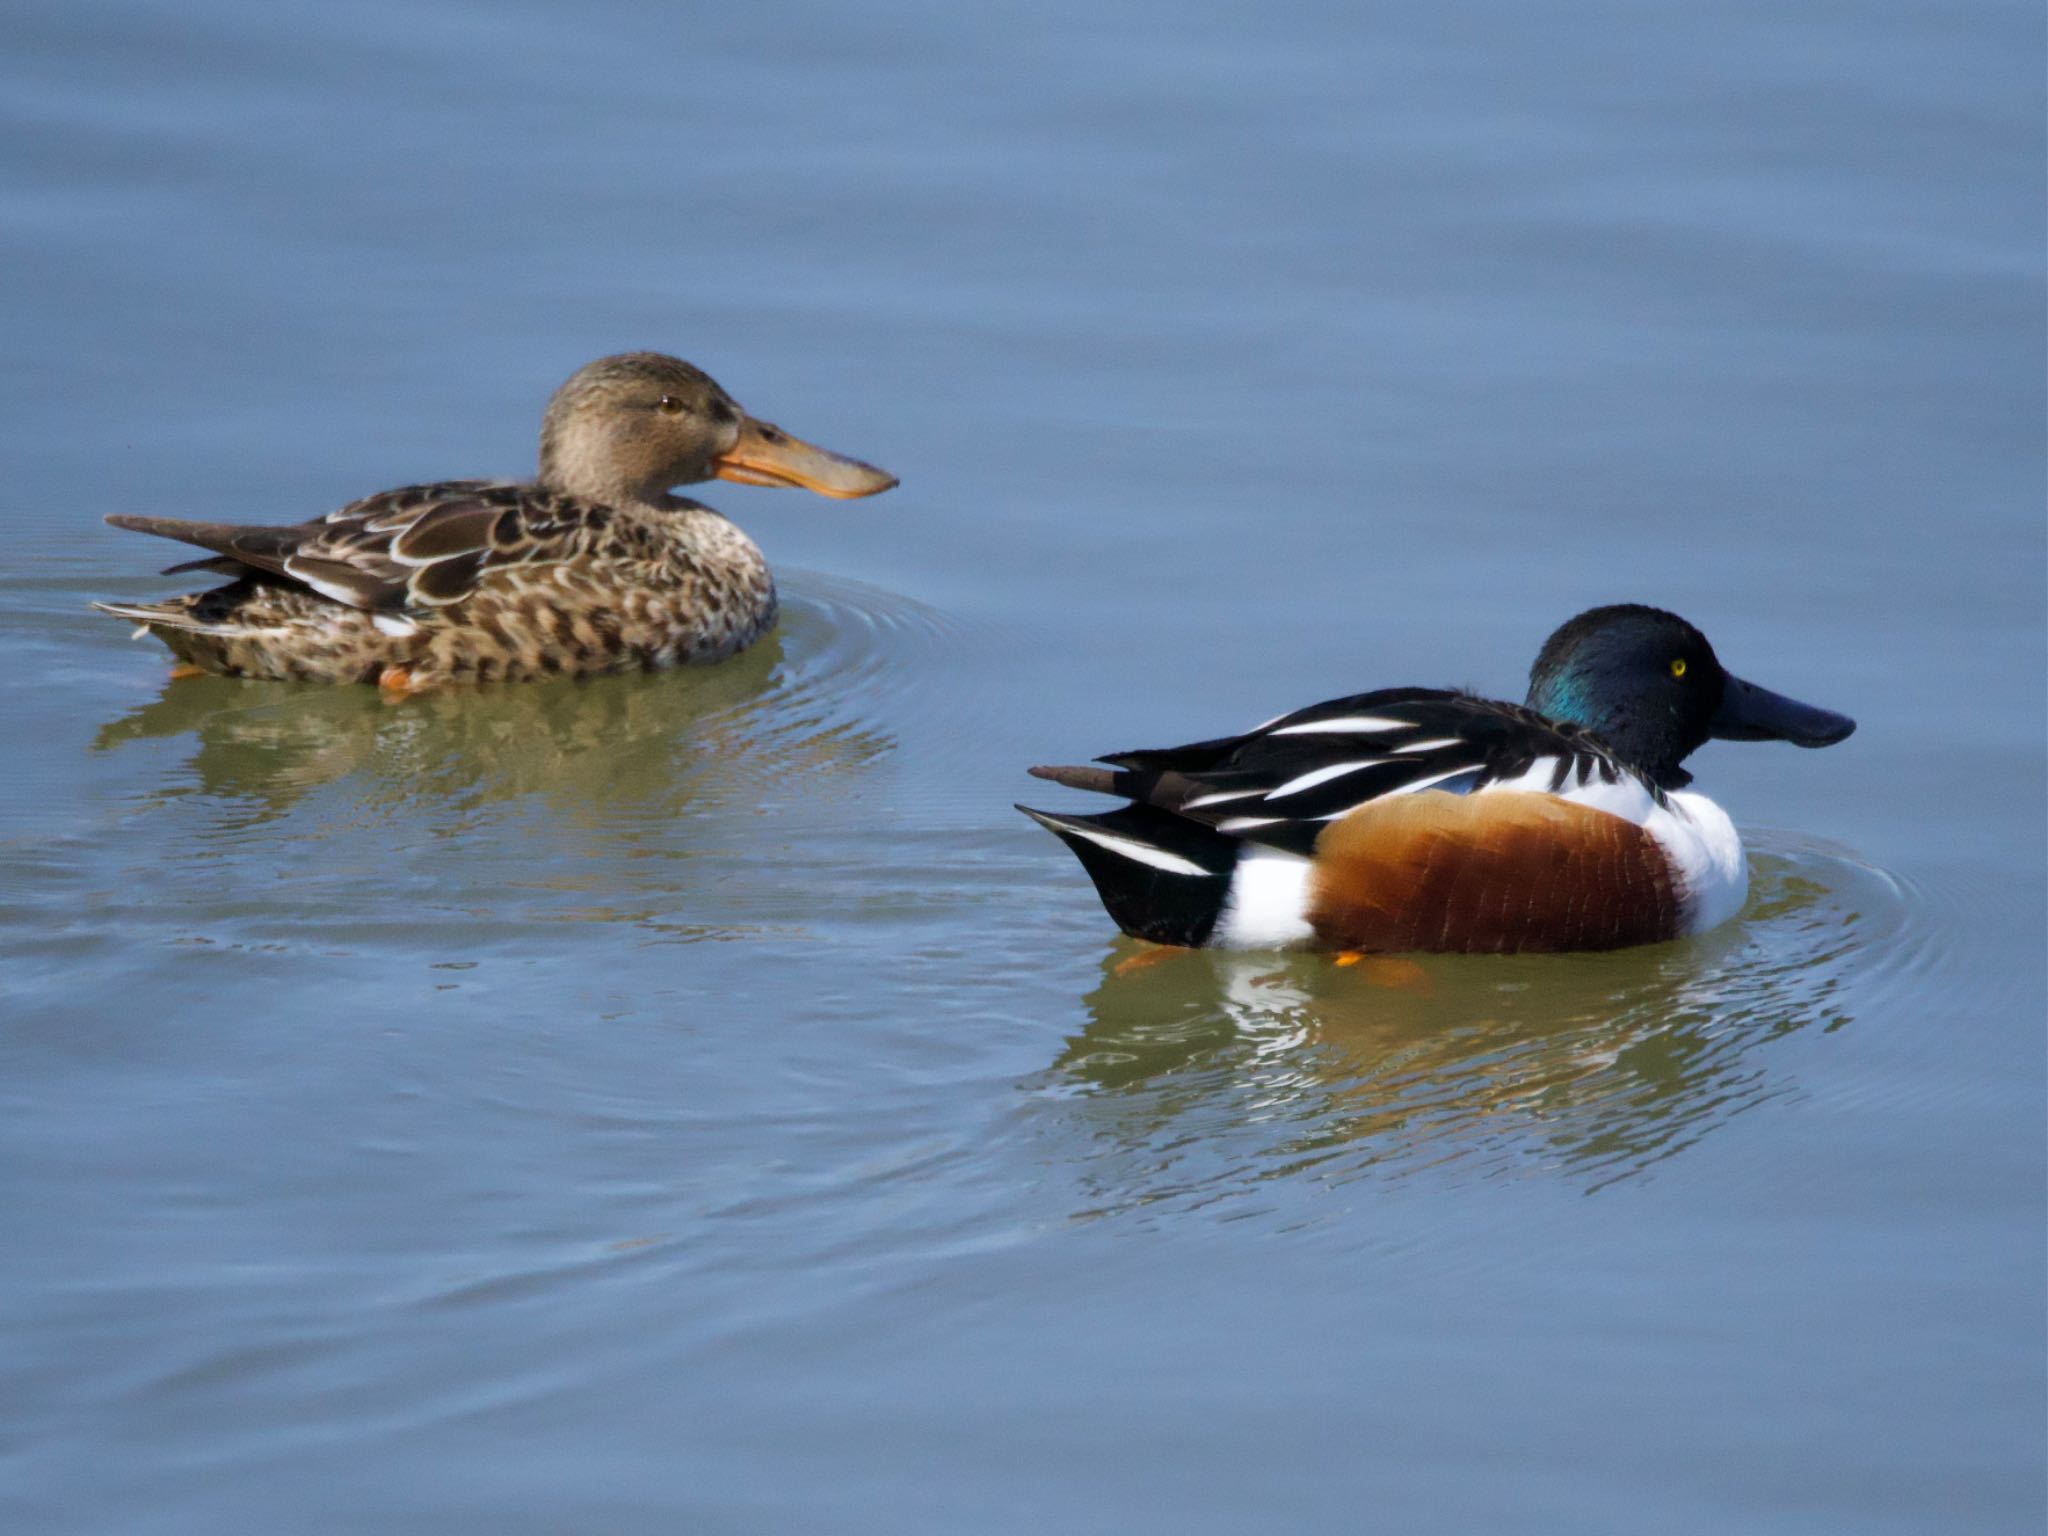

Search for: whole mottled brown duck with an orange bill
xmin=92 ymin=352 xmax=897 ymax=692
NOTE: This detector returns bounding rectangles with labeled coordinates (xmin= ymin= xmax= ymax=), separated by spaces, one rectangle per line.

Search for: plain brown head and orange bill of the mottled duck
xmin=541 ymin=352 xmax=897 ymax=502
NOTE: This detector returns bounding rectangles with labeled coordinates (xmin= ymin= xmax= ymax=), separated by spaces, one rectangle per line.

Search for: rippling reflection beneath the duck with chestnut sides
xmin=1040 ymin=852 xmax=1903 ymax=1210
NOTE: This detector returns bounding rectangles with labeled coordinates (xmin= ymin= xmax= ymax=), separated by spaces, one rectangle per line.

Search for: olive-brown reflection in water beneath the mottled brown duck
xmin=79 ymin=578 xmax=936 ymax=825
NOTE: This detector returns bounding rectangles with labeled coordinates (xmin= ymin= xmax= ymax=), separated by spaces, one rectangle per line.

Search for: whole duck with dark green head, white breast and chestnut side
xmin=1016 ymin=602 xmax=1855 ymax=956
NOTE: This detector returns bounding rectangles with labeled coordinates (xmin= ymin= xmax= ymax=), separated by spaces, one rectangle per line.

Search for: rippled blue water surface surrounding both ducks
xmin=0 ymin=0 xmax=2048 ymax=1536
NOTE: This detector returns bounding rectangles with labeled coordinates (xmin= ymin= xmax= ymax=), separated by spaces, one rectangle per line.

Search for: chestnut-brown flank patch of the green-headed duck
xmin=1309 ymin=791 xmax=1679 ymax=954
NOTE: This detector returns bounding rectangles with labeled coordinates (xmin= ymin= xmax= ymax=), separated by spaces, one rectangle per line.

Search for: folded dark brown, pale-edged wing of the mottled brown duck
xmin=106 ymin=479 xmax=614 ymax=612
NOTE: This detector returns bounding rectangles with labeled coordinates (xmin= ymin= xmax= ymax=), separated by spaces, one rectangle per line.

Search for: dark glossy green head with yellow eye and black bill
xmin=1528 ymin=602 xmax=1855 ymax=788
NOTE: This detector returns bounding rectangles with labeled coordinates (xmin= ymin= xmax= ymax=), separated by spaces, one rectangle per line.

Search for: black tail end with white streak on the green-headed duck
xmin=1018 ymin=798 xmax=1237 ymax=948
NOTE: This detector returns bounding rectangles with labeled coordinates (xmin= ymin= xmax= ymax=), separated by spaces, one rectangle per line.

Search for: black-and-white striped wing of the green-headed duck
xmin=1032 ymin=688 xmax=1636 ymax=854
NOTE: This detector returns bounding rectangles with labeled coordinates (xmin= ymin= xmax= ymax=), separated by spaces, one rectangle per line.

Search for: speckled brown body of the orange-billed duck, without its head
xmin=104 ymin=481 xmax=776 ymax=682
